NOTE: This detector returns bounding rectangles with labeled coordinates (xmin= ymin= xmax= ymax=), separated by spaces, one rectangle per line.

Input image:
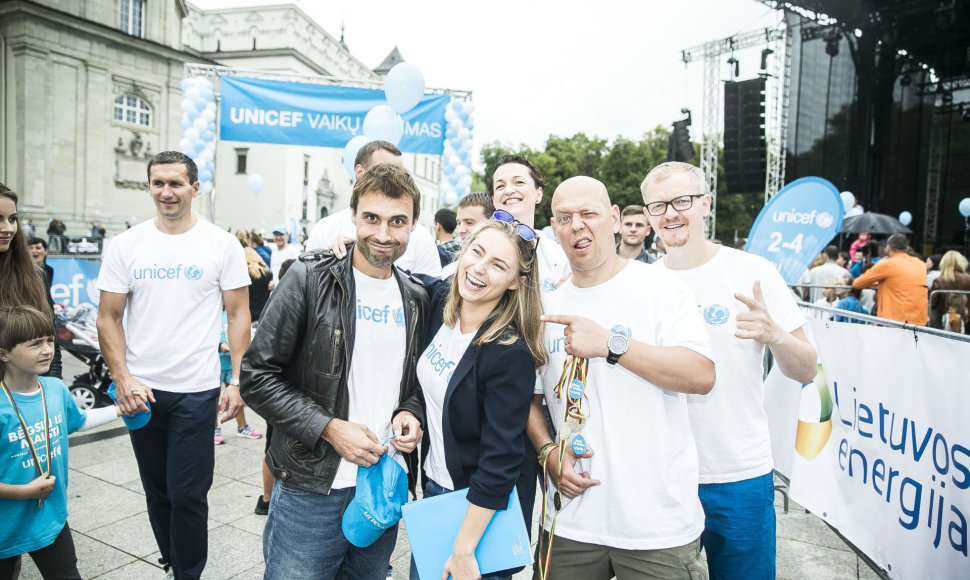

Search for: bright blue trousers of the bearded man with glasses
xmin=698 ymin=473 xmax=775 ymax=580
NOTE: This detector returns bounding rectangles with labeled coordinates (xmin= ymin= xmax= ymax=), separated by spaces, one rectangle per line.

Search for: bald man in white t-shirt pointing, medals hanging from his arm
xmin=529 ymin=177 xmax=714 ymax=580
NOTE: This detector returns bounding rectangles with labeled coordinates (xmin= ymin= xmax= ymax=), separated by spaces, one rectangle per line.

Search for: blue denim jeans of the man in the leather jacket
xmin=263 ymin=479 xmax=397 ymax=580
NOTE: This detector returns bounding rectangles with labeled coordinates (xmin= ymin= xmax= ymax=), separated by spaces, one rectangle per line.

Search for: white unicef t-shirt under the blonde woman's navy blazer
xmin=418 ymin=323 xmax=476 ymax=489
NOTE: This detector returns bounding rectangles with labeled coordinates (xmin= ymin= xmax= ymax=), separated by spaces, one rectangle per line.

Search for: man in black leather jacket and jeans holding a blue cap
xmin=240 ymin=163 xmax=428 ymax=578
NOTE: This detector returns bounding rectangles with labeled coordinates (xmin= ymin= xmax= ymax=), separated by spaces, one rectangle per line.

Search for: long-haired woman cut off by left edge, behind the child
xmin=0 ymin=183 xmax=61 ymax=378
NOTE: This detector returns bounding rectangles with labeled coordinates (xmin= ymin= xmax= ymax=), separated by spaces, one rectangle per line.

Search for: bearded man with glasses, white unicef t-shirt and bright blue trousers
xmin=641 ymin=162 xmax=816 ymax=579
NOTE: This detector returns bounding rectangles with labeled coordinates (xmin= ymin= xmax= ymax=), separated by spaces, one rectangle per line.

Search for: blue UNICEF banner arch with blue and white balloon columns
xmin=180 ymin=63 xmax=474 ymax=225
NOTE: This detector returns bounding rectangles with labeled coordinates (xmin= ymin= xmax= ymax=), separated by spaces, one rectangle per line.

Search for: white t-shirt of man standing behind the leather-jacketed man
xmin=306 ymin=207 xmax=441 ymax=278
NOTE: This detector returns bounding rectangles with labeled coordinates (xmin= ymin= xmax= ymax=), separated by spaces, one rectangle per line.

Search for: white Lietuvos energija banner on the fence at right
xmin=765 ymin=320 xmax=970 ymax=579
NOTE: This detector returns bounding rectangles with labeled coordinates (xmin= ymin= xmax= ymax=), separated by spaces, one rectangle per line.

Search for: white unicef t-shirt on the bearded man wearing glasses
xmin=657 ymin=246 xmax=805 ymax=483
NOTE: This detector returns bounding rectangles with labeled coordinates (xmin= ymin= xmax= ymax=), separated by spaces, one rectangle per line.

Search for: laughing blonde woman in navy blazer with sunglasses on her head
xmin=411 ymin=215 xmax=546 ymax=580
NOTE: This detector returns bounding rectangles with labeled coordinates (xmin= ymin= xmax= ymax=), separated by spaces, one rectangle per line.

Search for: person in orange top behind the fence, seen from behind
xmin=852 ymin=234 xmax=929 ymax=325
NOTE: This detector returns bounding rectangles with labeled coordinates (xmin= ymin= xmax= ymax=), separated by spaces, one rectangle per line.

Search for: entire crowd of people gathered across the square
xmin=0 ymin=141 xmax=970 ymax=580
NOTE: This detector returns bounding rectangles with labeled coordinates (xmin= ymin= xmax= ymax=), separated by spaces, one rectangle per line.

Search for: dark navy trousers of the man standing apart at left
xmin=128 ymin=389 xmax=219 ymax=580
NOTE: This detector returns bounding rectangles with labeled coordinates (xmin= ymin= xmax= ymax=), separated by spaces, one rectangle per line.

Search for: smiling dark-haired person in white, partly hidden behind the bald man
xmin=486 ymin=155 xmax=569 ymax=293
